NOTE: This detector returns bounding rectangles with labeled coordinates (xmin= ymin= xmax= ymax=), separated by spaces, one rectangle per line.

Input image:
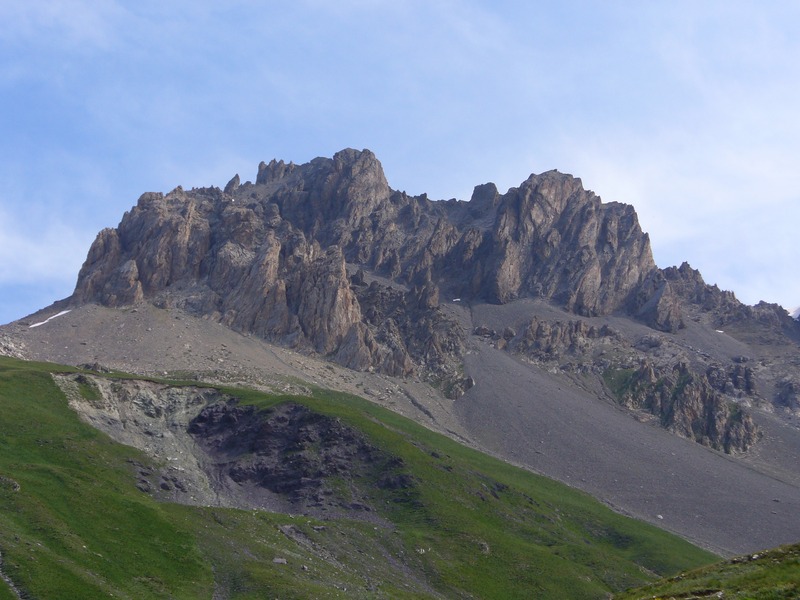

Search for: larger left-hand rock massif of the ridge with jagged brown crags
xmin=72 ymin=150 xmax=463 ymax=386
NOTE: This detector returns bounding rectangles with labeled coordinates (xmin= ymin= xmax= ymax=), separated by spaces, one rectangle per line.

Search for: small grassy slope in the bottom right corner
xmin=614 ymin=544 xmax=800 ymax=600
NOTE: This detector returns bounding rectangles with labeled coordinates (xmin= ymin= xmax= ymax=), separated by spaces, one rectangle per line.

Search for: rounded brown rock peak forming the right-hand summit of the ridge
xmin=484 ymin=171 xmax=655 ymax=316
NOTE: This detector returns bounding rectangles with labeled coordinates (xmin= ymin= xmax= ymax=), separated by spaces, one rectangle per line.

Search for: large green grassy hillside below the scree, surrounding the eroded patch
xmin=0 ymin=358 xmax=716 ymax=599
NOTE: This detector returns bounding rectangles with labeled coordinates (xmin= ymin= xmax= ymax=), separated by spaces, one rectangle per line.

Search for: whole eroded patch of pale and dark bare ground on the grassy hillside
xmin=55 ymin=374 xmax=415 ymax=519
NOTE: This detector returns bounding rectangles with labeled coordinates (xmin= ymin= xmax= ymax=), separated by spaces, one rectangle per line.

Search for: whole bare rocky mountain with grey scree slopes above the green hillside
xmin=6 ymin=149 xmax=800 ymax=553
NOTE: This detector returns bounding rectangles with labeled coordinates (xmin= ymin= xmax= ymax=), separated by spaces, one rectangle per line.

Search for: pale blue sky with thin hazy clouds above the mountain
xmin=0 ymin=0 xmax=800 ymax=323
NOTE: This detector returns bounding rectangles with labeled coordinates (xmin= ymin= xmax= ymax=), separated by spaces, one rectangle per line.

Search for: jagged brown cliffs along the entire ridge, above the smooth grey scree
xmin=70 ymin=150 xmax=798 ymax=448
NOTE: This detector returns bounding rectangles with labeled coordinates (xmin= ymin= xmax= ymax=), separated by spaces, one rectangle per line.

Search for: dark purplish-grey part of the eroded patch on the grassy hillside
xmin=188 ymin=401 xmax=414 ymax=520
